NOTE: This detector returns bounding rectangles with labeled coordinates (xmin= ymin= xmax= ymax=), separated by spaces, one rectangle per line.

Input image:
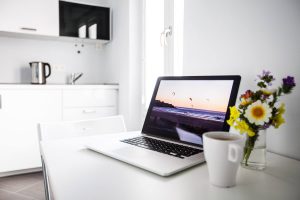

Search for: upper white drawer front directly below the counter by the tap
xmin=63 ymin=89 xmax=117 ymax=107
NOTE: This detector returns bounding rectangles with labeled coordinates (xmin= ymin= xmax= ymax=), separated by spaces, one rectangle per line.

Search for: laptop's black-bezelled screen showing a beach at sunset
xmin=142 ymin=76 xmax=240 ymax=146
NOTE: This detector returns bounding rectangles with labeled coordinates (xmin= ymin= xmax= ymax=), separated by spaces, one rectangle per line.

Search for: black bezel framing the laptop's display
xmin=142 ymin=75 xmax=241 ymax=147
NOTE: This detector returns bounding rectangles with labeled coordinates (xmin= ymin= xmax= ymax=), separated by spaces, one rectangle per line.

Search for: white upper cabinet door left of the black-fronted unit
xmin=0 ymin=0 xmax=59 ymax=36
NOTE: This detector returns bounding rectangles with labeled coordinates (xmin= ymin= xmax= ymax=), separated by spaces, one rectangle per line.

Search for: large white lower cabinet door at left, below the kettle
xmin=0 ymin=89 xmax=62 ymax=172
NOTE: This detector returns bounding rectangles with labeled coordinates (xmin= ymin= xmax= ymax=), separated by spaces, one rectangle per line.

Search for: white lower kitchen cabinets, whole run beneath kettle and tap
xmin=0 ymin=84 xmax=118 ymax=177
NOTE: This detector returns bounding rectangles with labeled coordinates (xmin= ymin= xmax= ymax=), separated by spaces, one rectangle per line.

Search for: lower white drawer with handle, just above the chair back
xmin=63 ymin=106 xmax=117 ymax=120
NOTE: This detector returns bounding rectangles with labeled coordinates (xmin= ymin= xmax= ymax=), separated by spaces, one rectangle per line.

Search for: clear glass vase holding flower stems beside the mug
xmin=241 ymin=130 xmax=267 ymax=170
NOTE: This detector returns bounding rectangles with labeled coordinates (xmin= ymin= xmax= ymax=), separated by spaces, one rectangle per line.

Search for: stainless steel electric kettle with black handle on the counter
xmin=29 ymin=62 xmax=51 ymax=84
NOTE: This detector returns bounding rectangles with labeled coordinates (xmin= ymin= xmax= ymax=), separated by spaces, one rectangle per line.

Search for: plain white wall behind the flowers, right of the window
xmin=183 ymin=0 xmax=300 ymax=159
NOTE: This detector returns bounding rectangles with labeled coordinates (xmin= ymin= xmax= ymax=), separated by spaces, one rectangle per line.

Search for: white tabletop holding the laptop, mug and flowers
xmin=41 ymin=132 xmax=300 ymax=200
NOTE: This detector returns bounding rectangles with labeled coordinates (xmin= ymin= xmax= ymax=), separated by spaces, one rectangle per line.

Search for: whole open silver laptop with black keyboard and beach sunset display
xmin=86 ymin=75 xmax=241 ymax=176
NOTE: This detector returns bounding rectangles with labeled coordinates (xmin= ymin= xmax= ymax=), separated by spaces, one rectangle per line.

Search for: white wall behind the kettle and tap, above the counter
xmin=0 ymin=37 xmax=106 ymax=83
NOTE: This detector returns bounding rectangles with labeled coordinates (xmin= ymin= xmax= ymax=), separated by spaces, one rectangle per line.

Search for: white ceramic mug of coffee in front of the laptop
xmin=203 ymin=131 xmax=244 ymax=187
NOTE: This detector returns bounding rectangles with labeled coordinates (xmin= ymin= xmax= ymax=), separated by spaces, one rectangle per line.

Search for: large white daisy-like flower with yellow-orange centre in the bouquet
xmin=245 ymin=101 xmax=272 ymax=125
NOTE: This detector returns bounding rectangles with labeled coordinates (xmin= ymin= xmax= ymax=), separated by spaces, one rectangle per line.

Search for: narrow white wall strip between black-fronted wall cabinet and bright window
xmin=105 ymin=0 xmax=142 ymax=130
